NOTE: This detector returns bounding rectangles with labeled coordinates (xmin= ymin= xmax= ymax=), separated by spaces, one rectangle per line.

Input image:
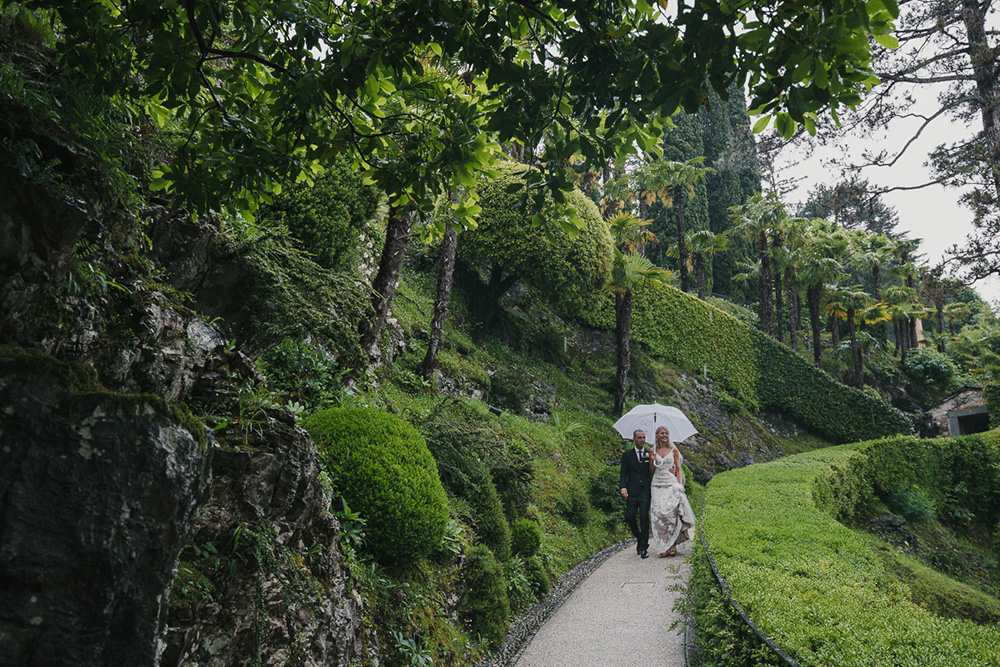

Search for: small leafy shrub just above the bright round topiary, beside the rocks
xmin=259 ymin=338 xmax=347 ymax=408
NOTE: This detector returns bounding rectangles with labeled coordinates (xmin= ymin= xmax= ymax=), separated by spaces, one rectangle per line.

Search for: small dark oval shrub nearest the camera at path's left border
xmin=458 ymin=546 xmax=510 ymax=648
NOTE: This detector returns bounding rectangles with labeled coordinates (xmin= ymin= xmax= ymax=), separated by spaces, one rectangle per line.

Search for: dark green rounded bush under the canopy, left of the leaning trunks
xmin=260 ymin=156 xmax=378 ymax=271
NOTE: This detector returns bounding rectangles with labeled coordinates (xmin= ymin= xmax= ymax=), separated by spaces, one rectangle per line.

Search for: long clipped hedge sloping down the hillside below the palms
xmin=590 ymin=284 xmax=912 ymax=442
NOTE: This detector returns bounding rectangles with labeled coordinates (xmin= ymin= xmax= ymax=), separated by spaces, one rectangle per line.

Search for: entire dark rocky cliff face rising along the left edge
xmin=0 ymin=126 xmax=368 ymax=666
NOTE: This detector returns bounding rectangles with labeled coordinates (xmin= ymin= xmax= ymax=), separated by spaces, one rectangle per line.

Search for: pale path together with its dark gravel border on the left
xmin=478 ymin=541 xmax=693 ymax=667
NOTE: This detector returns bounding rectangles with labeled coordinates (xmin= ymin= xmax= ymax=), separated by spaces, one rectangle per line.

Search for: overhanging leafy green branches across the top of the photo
xmin=23 ymin=0 xmax=898 ymax=220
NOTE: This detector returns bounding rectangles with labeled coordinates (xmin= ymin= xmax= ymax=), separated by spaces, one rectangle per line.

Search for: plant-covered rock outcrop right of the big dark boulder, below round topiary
xmin=162 ymin=411 xmax=361 ymax=667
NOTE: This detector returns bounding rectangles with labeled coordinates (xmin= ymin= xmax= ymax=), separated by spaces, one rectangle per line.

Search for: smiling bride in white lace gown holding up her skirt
xmin=649 ymin=426 xmax=694 ymax=558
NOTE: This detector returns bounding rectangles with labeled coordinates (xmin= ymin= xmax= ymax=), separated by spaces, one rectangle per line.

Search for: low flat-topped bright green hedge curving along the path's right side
xmin=699 ymin=433 xmax=1000 ymax=667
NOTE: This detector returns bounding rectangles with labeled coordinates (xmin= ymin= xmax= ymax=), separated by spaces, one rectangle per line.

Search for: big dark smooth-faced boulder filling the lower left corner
xmin=0 ymin=348 xmax=211 ymax=666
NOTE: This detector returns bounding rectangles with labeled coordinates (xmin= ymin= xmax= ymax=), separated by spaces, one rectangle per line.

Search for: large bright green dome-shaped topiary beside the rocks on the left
xmin=302 ymin=408 xmax=448 ymax=563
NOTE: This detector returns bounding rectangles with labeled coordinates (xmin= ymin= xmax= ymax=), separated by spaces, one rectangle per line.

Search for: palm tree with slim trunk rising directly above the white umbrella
xmin=608 ymin=213 xmax=671 ymax=414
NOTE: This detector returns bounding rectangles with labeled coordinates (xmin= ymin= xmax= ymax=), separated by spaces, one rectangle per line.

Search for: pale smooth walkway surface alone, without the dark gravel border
xmin=513 ymin=542 xmax=691 ymax=667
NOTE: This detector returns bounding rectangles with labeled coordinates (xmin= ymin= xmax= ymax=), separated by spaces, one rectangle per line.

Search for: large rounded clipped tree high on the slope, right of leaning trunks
xmin=459 ymin=164 xmax=612 ymax=314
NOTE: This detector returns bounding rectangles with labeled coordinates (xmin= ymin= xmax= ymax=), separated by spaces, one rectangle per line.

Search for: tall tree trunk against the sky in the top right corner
xmin=962 ymin=0 xmax=1000 ymax=197
